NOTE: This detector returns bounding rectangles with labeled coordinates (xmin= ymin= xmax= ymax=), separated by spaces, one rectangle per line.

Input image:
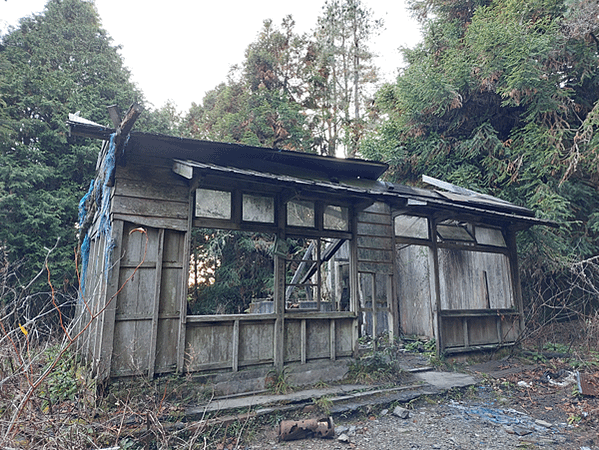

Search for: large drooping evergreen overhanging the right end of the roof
xmin=362 ymin=0 xmax=599 ymax=306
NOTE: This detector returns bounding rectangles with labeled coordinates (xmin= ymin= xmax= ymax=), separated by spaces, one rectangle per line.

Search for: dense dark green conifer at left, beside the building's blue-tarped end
xmin=0 ymin=0 xmax=142 ymax=296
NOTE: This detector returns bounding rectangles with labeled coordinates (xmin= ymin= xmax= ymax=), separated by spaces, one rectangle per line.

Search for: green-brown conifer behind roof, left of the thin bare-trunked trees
xmin=182 ymin=17 xmax=311 ymax=151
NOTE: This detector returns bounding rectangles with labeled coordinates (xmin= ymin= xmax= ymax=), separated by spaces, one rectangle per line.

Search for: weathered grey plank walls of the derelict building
xmin=78 ymin=154 xmax=520 ymax=378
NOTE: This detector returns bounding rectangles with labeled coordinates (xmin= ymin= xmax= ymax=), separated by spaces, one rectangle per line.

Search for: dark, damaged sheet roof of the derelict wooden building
xmin=67 ymin=116 xmax=556 ymax=228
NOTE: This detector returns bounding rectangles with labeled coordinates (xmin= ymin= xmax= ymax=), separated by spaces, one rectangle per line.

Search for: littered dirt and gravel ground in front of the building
xmin=246 ymin=359 xmax=599 ymax=450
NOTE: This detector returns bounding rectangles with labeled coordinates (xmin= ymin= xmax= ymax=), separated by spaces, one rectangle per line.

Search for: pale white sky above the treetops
xmin=0 ymin=0 xmax=420 ymax=112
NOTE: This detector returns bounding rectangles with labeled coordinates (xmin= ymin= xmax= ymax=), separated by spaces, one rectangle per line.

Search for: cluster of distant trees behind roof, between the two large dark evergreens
xmin=181 ymin=0 xmax=380 ymax=156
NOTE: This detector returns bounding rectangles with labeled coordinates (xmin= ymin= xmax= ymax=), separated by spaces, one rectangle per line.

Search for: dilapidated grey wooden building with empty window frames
xmin=69 ymin=110 xmax=544 ymax=388
